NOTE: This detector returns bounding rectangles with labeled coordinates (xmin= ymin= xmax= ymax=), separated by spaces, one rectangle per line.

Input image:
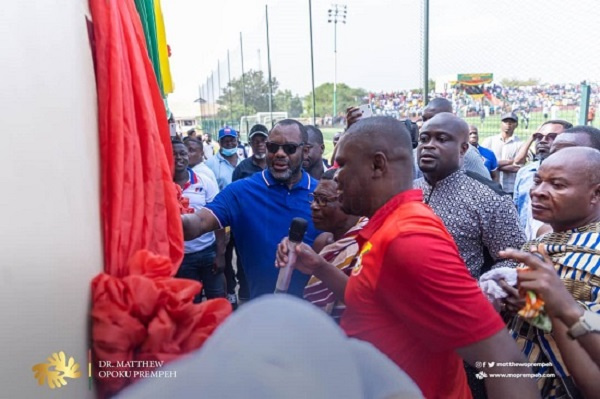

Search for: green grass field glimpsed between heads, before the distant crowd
xmin=321 ymin=110 xmax=600 ymax=160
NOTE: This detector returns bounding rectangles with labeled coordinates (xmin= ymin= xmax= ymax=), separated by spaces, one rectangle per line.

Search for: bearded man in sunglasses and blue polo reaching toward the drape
xmin=182 ymin=119 xmax=320 ymax=299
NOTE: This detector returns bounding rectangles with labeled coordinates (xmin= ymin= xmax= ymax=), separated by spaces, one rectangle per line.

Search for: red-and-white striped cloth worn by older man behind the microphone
xmin=304 ymin=217 xmax=369 ymax=324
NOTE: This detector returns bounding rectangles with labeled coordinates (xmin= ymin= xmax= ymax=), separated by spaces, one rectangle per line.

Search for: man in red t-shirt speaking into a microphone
xmin=277 ymin=117 xmax=539 ymax=398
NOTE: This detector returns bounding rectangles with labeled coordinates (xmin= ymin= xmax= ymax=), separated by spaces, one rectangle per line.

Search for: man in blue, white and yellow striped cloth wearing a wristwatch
xmin=504 ymin=148 xmax=600 ymax=399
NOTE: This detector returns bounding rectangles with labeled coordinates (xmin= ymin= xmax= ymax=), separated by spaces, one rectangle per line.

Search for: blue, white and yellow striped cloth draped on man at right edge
xmin=508 ymin=222 xmax=600 ymax=399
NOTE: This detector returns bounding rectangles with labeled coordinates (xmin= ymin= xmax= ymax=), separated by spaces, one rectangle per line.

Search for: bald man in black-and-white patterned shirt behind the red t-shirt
xmin=415 ymin=113 xmax=525 ymax=278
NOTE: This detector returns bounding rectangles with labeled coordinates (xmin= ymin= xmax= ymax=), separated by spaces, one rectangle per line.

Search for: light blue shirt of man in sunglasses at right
xmin=513 ymin=161 xmax=544 ymax=240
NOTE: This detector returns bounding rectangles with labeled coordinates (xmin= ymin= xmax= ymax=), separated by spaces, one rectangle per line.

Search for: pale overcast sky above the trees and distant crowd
xmin=162 ymin=0 xmax=600 ymax=101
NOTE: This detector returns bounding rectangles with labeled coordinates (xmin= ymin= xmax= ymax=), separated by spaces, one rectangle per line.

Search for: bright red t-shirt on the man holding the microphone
xmin=341 ymin=190 xmax=505 ymax=398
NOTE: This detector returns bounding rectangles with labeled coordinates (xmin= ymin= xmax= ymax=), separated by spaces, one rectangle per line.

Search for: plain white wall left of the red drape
xmin=0 ymin=0 xmax=102 ymax=398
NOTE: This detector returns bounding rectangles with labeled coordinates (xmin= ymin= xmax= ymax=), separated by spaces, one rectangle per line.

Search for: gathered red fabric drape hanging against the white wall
xmin=90 ymin=0 xmax=231 ymax=396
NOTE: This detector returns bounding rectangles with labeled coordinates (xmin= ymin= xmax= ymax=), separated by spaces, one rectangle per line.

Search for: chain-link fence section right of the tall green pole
xmin=421 ymin=0 xmax=600 ymax=144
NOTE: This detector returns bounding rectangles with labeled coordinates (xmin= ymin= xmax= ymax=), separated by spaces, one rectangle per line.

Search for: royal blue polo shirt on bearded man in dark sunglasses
xmin=206 ymin=169 xmax=321 ymax=298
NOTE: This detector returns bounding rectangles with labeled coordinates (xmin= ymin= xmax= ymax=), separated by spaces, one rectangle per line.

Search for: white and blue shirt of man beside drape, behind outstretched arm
xmin=182 ymin=168 xmax=219 ymax=254
